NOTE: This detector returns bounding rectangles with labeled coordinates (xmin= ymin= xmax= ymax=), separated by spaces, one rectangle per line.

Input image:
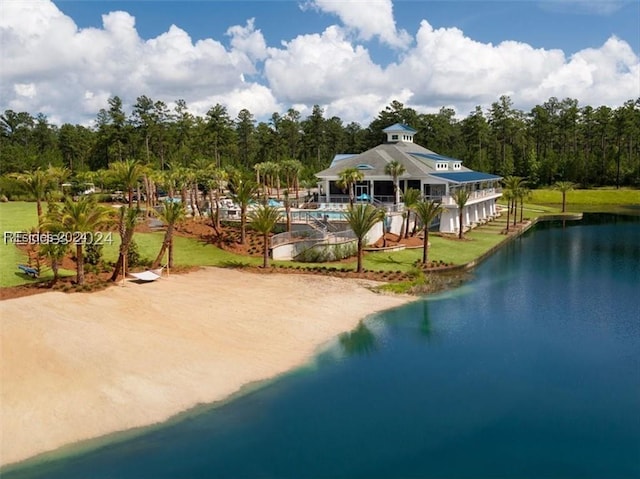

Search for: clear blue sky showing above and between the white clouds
xmin=55 ymin=0 xmax=640 ymax=57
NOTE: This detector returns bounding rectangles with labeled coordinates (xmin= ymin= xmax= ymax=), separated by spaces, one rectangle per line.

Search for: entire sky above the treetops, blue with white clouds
xmin=0 ymin=0 xmax=640 ymax=124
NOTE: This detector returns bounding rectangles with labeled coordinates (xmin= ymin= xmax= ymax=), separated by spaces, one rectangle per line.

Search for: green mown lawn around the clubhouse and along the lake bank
xmin=0 ymin=189 xmax=640 ymax=287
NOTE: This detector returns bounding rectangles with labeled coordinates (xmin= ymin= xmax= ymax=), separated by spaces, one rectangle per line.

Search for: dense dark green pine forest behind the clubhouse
xmin=0 ymin=96 xmax=640 ymax=187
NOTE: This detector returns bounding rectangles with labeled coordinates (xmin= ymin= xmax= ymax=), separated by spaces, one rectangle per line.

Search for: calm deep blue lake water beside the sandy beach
xmin=3 ymin=215 xmax=640 ymax=479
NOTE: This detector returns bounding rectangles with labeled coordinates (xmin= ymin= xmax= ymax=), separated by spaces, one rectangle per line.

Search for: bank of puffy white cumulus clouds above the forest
xmin=0 ymin=0 xmax=640 ymax=125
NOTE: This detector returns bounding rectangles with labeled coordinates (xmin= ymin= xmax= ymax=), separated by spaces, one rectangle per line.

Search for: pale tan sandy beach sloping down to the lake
xmin=0 ymin=268 xmax=411 ymax=465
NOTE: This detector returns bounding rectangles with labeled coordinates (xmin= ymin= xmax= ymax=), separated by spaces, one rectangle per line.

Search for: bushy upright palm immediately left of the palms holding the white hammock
xmin=61 ymin=196 xmax=111 ymax=284
